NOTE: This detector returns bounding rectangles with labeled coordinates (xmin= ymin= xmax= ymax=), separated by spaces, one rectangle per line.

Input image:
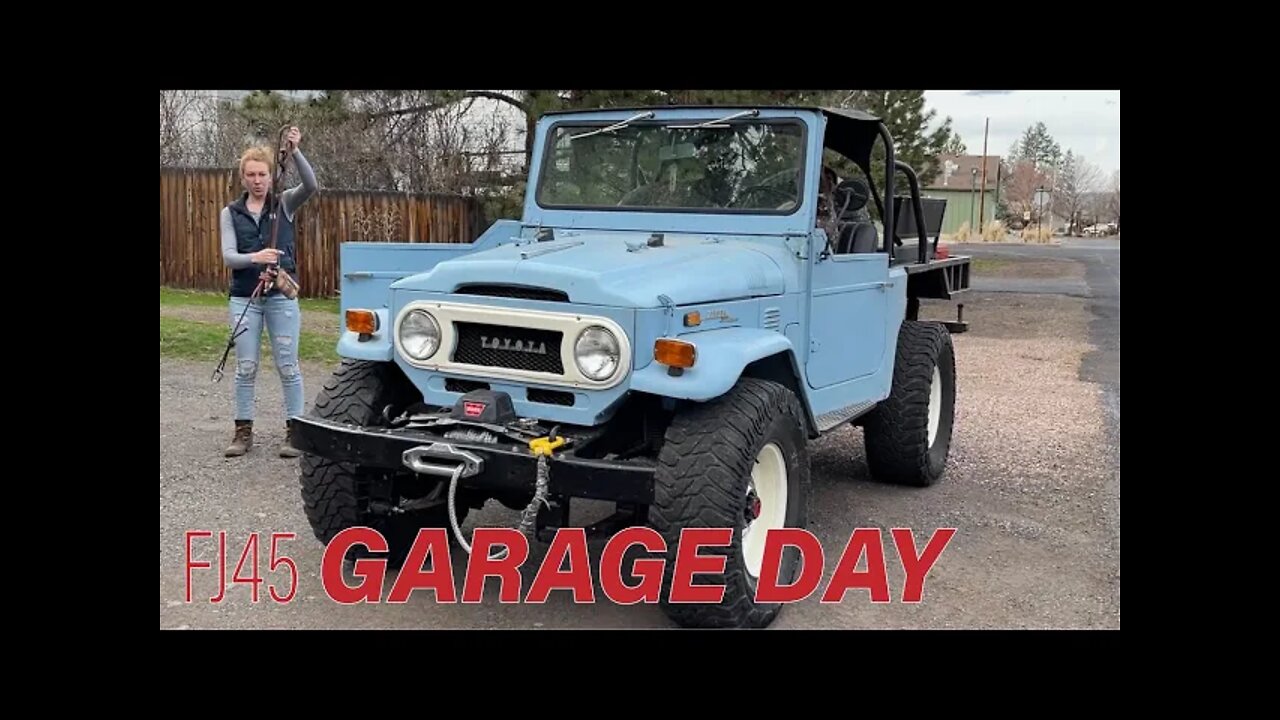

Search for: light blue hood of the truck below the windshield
xmin=394 ymin=232 xmax=787 ymax=307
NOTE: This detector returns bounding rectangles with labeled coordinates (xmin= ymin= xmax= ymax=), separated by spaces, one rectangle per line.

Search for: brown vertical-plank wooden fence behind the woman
xmin=160 ymin=168 xmax=485 ymax=297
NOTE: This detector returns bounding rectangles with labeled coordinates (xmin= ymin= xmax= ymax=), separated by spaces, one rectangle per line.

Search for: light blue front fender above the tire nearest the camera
xmin=631 ymin=328 xmax=804 ymax=402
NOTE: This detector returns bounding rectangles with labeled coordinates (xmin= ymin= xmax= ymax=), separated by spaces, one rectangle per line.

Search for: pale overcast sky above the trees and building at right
xmin=924 ymin=90 xmax=1120 ymax=177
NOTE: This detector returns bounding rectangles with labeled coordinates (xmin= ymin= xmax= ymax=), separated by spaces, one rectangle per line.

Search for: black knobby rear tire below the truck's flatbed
xmin=863 ymin=320 xmax=956 ymax=487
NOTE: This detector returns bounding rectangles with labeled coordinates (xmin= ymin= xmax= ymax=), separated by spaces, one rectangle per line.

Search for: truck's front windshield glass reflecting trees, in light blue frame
xmin=538 ymin=117 xmax=805 ymax=214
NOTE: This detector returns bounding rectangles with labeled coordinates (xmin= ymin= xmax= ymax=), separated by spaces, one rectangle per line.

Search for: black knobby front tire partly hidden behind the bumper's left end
xmin=298 ymin=359 xmax=467 ymax=565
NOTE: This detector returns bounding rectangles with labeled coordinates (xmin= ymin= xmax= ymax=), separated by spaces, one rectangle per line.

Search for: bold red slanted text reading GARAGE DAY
xmin=321 ymin=527 xmax=955 ymax=605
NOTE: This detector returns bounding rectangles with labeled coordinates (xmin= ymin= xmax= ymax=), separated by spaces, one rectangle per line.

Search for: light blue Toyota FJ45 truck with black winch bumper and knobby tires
xmin=294 ymin=106 xmax=969 ymax=626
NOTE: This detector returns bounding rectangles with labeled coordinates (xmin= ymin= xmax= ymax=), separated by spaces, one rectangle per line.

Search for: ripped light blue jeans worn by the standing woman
xmin=229 ymin=295 xmax=303 ymax=420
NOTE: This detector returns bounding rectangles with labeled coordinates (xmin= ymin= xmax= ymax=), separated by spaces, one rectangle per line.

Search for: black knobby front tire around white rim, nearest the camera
xmin=649 ymin=378 xmax=809 ymax=628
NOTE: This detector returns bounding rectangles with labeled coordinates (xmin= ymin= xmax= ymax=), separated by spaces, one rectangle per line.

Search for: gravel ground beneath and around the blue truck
xmin=160 ymin=254 xmax=1120 ymax=629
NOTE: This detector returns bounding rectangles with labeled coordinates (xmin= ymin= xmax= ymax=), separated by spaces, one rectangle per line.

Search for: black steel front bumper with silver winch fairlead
xmin=286 ymin=418 xmax=654 ymax=505
